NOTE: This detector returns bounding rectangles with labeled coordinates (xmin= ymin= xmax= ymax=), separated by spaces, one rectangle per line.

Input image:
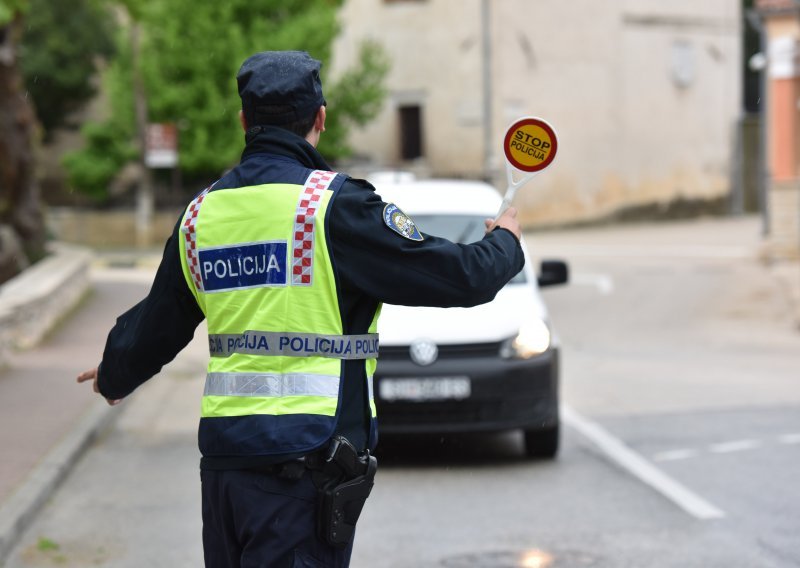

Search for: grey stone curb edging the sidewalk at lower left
xmin=0 ymin=402 xmax=119 ymax=566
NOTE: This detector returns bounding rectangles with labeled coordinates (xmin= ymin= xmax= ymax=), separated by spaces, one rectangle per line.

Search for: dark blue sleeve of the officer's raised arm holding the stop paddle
xmin=330 ymin=180 xmax=525 ymax=307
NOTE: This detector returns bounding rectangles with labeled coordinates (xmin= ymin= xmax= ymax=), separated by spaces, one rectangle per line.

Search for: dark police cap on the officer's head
xmin=236 ymin=51 xmax=325 ymax=126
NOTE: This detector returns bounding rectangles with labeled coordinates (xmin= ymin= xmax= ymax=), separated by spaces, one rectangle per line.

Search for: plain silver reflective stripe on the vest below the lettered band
xmin=203 ymin=373 xmax=339 ymax=398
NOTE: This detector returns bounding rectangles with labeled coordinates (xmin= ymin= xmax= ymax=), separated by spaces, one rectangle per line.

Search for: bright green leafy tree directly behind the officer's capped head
xmin=66 ymin=0 xmax=388 ymax=201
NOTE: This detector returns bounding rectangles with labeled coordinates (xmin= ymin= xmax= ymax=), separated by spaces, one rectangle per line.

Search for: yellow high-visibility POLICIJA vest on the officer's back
xmin=180 ymin=171 xmax=378 ymax=455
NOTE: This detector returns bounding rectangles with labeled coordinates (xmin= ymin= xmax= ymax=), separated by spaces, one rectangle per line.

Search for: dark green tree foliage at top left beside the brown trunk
xmin=20 ymin=0 xmax=115 ymax=138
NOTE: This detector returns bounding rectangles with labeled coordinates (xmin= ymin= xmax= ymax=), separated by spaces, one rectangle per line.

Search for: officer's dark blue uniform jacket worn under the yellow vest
xmin=98 ymin=127 xmax=524 ymax=469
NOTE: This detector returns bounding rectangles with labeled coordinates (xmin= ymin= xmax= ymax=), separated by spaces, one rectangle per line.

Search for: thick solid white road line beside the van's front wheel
xmin=561 ymin=405 xmax=725 ymax=520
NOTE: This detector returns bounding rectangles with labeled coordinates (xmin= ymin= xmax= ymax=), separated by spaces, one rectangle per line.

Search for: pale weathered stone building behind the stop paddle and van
xmin=331 ymin=0 xmax=742 ymax=225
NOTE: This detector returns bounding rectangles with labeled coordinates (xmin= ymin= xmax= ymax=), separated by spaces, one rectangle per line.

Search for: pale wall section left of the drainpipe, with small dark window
xmin=331 ymin=0 xmax=483 ymax=176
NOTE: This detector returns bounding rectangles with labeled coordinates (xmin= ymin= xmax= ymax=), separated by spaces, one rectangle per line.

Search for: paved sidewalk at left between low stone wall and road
xmin=0 ymin=271 xmax=151 ymax=565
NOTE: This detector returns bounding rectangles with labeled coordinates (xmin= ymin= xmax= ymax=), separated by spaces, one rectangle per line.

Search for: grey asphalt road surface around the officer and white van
xmin=7 ymin=215 xmax=800 ymax=568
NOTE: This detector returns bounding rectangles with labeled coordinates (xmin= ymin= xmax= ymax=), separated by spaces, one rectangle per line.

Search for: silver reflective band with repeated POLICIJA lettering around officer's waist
xmin=208 ymin=330 xmax=378 ymax=359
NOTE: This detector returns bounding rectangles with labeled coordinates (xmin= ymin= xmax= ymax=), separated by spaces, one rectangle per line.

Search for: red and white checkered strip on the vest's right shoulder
xmin=292 ymin=170 xmax=336 ymax=286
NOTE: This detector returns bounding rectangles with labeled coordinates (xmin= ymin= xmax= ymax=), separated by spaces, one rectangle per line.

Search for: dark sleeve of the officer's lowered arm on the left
xmin=79 ymin=227 xmax=204 ymax=402
